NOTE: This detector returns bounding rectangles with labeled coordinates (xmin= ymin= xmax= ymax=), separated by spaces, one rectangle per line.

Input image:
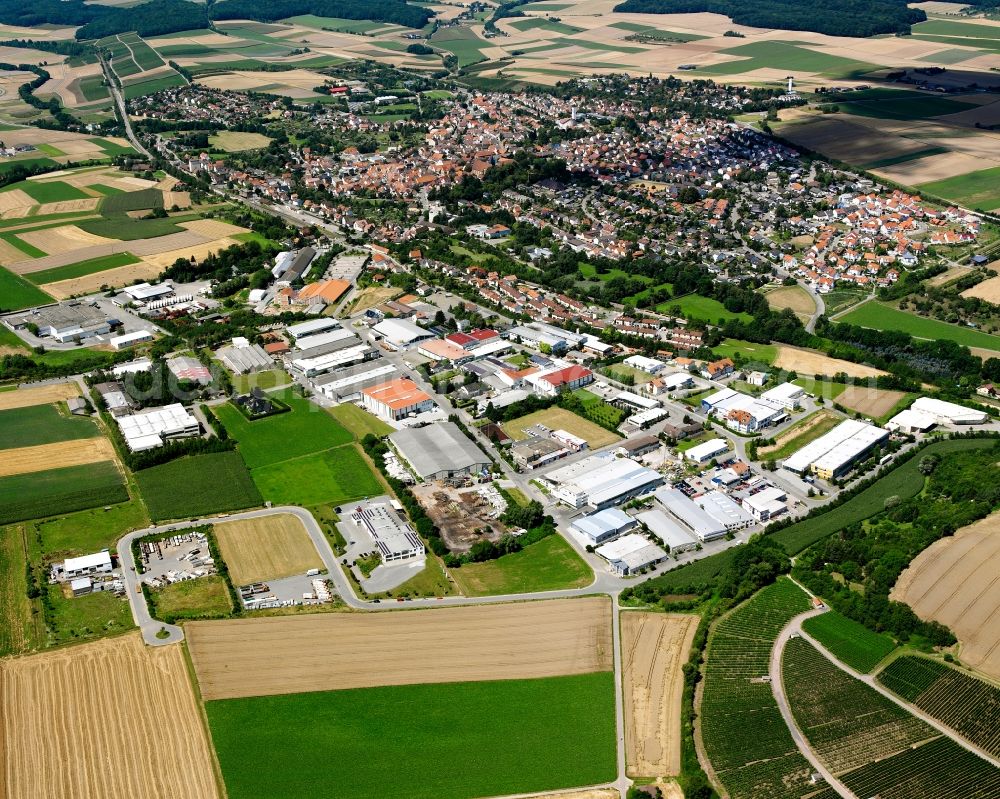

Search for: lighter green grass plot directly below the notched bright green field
xmin=251 ymin=444 xmax=385 ymax=505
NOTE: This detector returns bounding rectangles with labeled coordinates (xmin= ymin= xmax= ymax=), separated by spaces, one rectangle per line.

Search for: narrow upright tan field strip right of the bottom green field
xmin=621 ymin=611 xmax=698 ymax=777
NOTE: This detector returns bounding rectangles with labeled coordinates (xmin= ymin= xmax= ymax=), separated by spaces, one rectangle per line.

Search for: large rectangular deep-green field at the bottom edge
xmin=205 ymin=672 xmax=615 ymax=799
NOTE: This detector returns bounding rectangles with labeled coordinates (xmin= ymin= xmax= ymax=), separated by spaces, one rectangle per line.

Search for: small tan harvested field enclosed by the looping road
xmin=215 ymin=513 xmax=323 ymax=585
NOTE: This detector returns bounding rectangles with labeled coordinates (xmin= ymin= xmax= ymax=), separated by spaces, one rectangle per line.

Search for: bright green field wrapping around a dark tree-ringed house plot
xmin=214 ymin=391 xmax=354 ymax=469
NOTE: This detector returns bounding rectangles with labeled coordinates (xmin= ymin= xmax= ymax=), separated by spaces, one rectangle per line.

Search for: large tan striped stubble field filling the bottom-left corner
xmin=0 ymin=633 xmax=219 ymax=799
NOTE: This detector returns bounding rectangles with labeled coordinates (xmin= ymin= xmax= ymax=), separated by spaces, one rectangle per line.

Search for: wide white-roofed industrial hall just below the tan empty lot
xmin=545 ymin=453 xmax=663 ymax=510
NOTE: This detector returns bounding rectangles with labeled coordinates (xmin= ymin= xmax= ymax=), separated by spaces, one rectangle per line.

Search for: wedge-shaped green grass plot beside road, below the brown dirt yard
xmin=451 ymin=533 xmax=594 ymax=596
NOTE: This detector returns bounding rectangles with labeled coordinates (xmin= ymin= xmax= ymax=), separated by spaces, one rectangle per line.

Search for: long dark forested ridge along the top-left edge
xmin=0 ymin=0 xmax=433 ymax=39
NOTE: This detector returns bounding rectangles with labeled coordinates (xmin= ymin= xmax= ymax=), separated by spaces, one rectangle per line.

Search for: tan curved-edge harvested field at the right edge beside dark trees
xmin=889 ymin=514 xmax=1000 ymax=679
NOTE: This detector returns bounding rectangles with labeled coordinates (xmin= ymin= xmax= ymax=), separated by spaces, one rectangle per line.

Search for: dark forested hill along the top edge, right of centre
xmin=614 ymin=0 xmax=924 ymax=37
